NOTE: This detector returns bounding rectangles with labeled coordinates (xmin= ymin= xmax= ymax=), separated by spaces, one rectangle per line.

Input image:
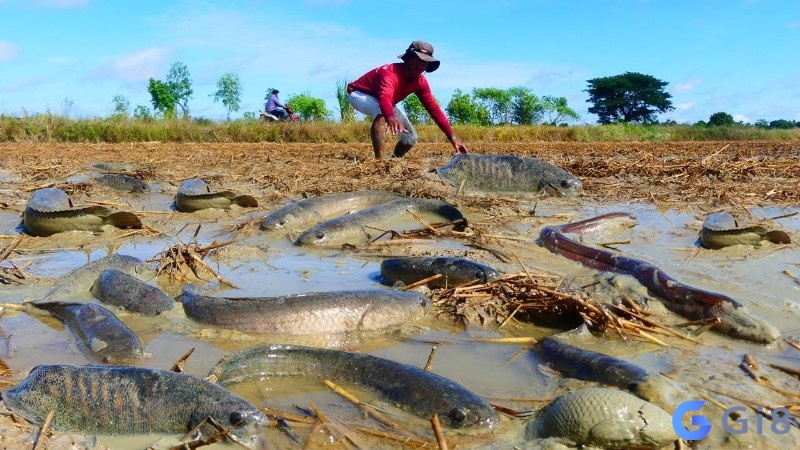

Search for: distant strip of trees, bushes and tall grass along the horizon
xmin=0 ymin=62 xmax=800 ymax=143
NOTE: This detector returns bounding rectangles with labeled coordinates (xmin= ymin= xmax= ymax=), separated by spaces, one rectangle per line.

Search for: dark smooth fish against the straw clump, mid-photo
xmin=381 ymin=256 xmax=500 ymax=289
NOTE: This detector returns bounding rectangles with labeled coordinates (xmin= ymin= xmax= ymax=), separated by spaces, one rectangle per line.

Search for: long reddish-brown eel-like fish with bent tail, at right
xmin=539 ymin=212 xmax=781 ymax=344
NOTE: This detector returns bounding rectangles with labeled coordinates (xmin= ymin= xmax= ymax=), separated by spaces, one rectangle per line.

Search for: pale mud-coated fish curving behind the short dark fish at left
xmin=42 ymin=253 xmax=155 ymax=301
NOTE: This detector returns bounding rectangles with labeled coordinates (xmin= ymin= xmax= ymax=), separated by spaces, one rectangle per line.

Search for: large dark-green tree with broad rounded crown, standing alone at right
xmin=584 ymin=72 xmax=675 ymax=124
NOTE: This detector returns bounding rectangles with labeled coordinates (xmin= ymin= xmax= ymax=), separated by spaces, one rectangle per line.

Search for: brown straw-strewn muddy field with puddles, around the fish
xmin=0 ymin=142 xmax=800 ymax=448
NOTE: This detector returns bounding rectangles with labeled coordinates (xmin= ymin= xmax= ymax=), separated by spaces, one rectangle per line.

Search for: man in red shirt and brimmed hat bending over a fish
xmin=347 ymin=41 xmax=467 ymax=159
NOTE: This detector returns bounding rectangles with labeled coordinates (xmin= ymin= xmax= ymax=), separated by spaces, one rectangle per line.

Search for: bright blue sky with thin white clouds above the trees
xmin=0 ymin=0 xmax=800 ymax=123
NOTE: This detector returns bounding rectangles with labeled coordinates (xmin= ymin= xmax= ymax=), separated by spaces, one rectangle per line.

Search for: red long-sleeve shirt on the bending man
xmin=347 ymin=63 xmax=453 ymax=141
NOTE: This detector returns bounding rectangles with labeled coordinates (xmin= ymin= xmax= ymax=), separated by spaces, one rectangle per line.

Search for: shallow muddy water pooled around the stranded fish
xmin=0 ymin=174 xmax=800 ymax=448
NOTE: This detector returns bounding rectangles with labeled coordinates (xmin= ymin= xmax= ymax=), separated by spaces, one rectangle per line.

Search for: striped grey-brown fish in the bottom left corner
xmin=0 ymin=364 xmax=268 ymax=442
